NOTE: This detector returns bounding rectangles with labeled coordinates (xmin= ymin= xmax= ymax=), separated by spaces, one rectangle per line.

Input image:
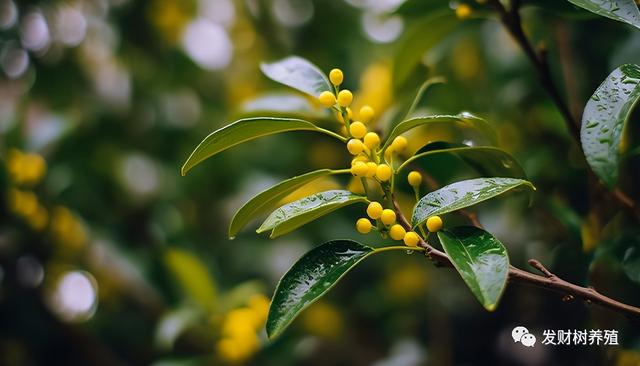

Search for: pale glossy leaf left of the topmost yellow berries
xmin=260 ymin=56 xmax=333 ymax=98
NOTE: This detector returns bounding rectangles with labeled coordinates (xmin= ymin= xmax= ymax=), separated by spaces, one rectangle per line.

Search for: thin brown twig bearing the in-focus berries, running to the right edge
xmin=391 ymin=195 xmax=640 ymax=318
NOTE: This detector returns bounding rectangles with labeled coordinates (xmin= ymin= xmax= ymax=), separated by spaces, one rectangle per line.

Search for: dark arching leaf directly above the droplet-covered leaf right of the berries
xmin=397 ymin=141 xmax=527 ymax=179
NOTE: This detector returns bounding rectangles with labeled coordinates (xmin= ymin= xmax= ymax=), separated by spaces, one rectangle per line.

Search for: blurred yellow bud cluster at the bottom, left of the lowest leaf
xmin=216 ymin=294 xmax=269 ymax=363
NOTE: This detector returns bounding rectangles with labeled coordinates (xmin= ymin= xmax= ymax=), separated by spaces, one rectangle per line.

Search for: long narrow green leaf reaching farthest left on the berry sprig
xmin=182 ymin=117 xmax=346 ymax=175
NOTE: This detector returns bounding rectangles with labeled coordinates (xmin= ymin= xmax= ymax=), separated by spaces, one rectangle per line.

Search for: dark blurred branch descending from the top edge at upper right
xmin=489 ymin=0 xmax=640 ymax=222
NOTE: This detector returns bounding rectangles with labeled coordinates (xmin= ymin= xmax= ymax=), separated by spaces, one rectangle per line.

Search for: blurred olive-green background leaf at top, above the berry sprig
xmin=393 ymin=9 xmax=458 ymax=89
